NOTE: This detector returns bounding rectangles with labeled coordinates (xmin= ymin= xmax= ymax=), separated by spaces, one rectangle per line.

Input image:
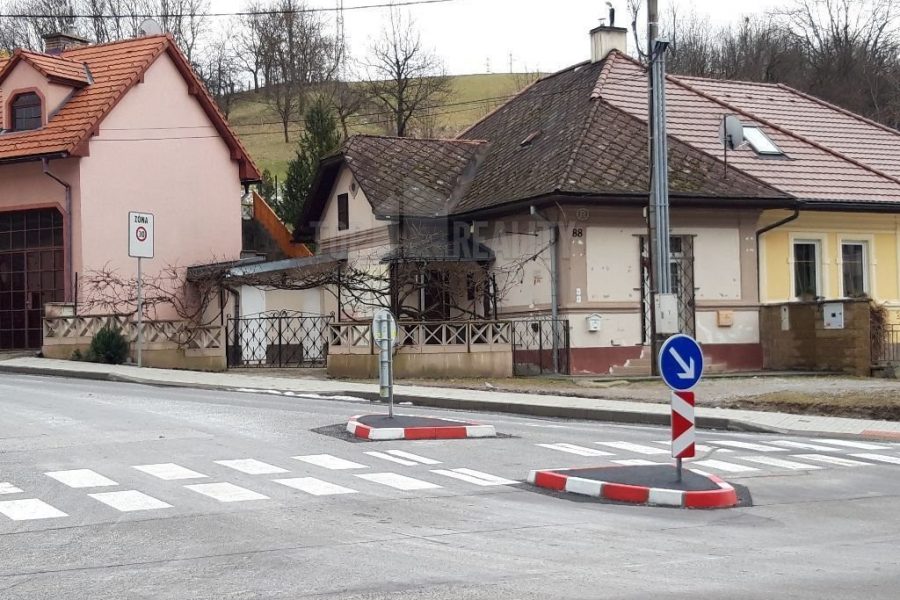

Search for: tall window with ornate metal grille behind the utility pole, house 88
xmin=640 ymin=235 xmax=697 ymax=344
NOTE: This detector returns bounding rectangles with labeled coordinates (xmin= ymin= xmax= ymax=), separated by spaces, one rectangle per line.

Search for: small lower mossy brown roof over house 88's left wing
xmin=343 ymin=135 xmax=485 ymax=217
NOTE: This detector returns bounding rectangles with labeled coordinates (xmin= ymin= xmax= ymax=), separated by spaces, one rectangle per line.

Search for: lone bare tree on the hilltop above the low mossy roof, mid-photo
xmin=363 ymin=9 xmax=452 ymax=137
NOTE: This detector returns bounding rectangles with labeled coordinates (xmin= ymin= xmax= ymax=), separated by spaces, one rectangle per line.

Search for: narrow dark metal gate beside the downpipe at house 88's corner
xmin=510 ymin=318 xmax=569 ymax=375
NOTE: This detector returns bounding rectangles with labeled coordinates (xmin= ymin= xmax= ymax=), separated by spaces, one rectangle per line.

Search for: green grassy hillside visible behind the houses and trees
xmin=229 ymin=73 xmax=528 ymax=180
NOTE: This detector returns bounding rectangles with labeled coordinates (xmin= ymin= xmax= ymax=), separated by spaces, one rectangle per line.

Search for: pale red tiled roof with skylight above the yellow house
xmin=594 ymin=53 xmax=900 ymax=202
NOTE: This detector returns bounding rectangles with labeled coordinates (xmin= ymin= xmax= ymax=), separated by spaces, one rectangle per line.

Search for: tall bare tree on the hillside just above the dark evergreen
xmin=262 ymin=0 xmax=342 ymax=143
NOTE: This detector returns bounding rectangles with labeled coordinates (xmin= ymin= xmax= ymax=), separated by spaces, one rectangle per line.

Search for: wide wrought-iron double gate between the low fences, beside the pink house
xmin=226 ymin=311 xmax=331 ymax=369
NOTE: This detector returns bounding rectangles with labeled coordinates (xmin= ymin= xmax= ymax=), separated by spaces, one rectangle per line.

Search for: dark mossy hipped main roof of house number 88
xmin=457 ymin=62 xmax=784 ymax=212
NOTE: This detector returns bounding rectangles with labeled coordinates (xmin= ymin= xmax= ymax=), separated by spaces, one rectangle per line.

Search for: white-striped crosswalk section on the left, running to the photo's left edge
xmin=0 ymin=449 xmax=520 ymax=526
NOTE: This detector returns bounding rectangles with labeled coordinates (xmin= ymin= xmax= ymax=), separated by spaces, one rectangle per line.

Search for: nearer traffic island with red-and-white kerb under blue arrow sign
xmin=528 ymin=465 xmax=738 ymax=508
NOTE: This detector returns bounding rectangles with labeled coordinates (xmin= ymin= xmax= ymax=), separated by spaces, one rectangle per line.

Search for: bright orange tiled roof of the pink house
xmin=0 ymin=35 xmax=259 ymax=182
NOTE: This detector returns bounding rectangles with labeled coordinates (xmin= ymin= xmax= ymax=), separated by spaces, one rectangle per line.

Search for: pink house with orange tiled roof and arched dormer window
xmin=0 ymin=35 xmax=259 ymax=350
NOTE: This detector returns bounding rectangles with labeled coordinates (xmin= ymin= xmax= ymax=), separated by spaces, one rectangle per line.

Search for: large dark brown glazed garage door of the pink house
xmin=0 ymin=208 xmax=65 ymax=350
